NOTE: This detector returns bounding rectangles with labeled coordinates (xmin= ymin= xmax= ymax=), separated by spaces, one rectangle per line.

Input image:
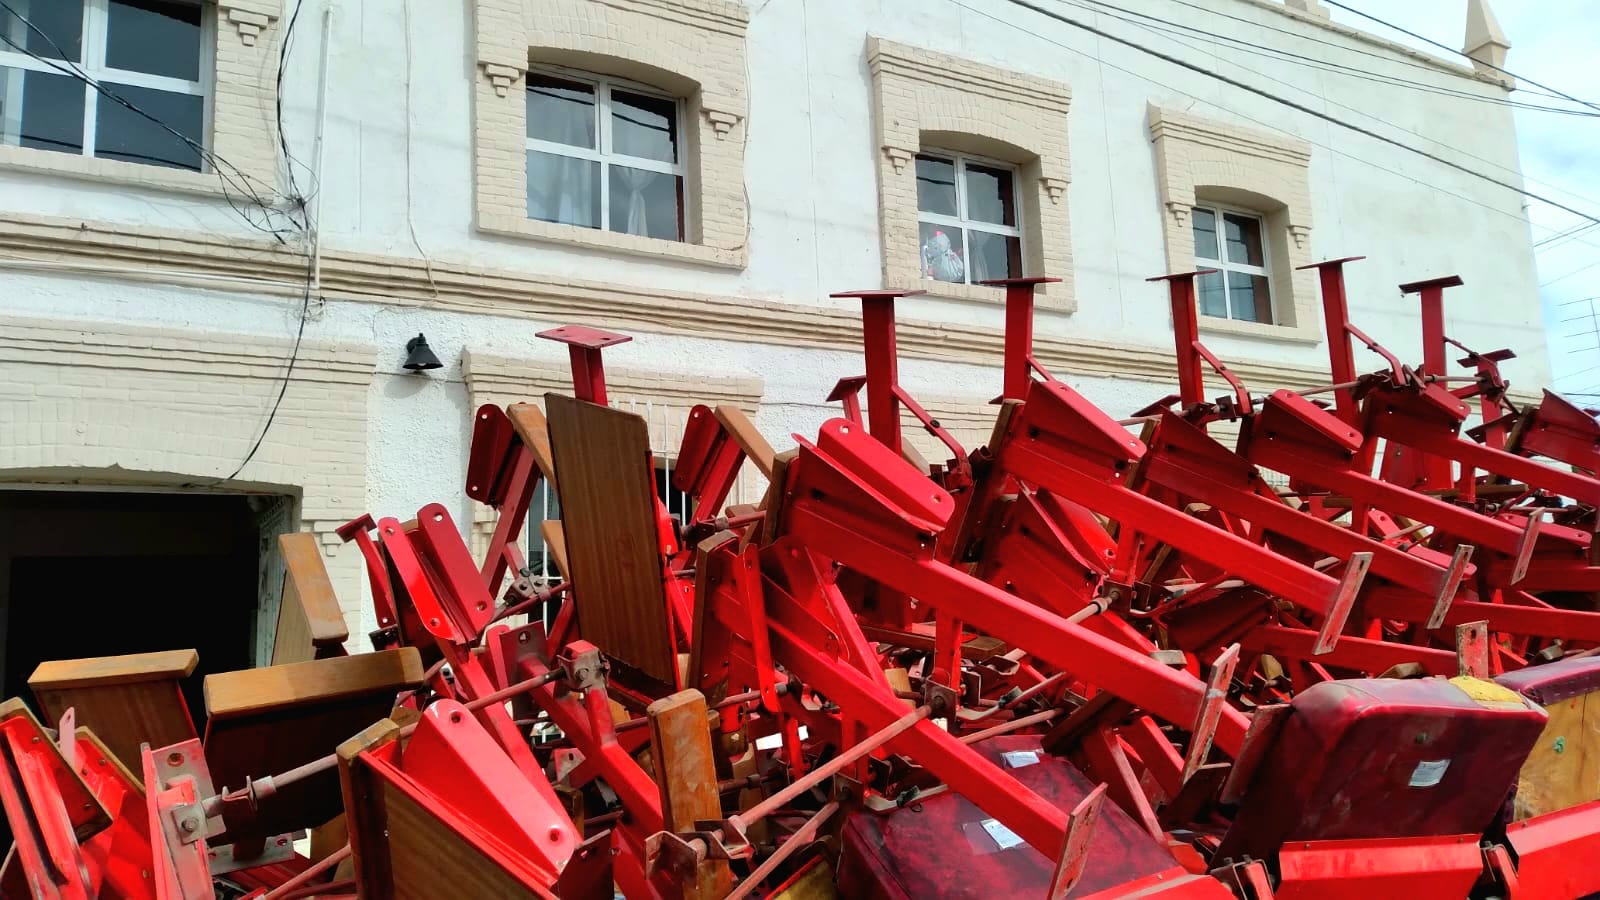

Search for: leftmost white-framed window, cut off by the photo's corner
xmin=0 ymin=0 xmax=214 ymax=171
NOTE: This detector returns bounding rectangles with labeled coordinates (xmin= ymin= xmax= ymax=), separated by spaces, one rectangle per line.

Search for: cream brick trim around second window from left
xmin=472 ymin=0 xmax=749 ymax=269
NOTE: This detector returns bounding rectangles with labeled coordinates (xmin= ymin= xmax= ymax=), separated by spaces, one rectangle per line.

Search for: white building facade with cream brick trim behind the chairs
xmin=0 ymin=0 xmax=1549 ymax=649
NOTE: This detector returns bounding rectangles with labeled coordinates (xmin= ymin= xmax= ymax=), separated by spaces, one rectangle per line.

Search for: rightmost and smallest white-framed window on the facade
xmin=1190 ymin=207 xmax=1272 ymax=325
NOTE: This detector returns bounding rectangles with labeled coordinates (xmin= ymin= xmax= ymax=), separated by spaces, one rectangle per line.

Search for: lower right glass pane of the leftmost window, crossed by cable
xmin=94 ymin=83 xmax=205 ymax=171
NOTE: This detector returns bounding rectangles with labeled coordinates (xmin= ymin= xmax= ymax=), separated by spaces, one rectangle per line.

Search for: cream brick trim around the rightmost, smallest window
xmin=1147 ymin=104 xmax=1322 ymax=344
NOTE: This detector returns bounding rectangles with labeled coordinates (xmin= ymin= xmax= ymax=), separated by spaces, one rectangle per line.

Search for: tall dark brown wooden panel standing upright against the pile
xmin=544 ymin=394 xmax=677 ymax=685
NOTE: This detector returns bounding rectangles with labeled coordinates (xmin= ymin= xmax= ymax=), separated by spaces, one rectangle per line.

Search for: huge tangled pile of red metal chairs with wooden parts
xmin=0 ymin=259 xmax=1600 ymax=900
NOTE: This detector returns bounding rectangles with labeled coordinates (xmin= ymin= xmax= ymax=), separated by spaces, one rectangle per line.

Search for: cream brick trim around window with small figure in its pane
xmin=867 ymin=35 xmax=1075 ymax=312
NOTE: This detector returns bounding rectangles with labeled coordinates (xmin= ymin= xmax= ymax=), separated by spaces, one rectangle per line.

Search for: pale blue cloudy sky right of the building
xmin=1330 ymin=0 xmax=1600 ymax=397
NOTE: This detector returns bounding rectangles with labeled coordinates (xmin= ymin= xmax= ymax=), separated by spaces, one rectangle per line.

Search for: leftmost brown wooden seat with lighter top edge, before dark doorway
xmin=27 ymin=650 xmax=200 ymax=772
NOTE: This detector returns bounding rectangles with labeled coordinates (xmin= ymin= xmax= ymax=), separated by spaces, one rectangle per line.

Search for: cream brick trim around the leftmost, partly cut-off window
xmin=0 ymin=0 xmax=283 ymax=197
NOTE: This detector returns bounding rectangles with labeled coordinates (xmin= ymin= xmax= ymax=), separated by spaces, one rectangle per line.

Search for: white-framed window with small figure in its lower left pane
xmin=917 ymin=154 xmax=1022 ymax=283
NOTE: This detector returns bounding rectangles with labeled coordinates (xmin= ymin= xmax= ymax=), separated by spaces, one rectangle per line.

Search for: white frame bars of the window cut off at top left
xmin=0 ymin=0 xmax=216 ymax=171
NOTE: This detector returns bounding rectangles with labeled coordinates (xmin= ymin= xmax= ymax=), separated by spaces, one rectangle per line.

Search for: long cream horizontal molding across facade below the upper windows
xmin=0 ymin=213 xmax=1538 ymax=399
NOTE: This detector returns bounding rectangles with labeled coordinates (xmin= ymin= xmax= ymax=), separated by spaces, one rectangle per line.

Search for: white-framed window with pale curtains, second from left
xmin=528 ymin=72 xmax=683 ymax=240
